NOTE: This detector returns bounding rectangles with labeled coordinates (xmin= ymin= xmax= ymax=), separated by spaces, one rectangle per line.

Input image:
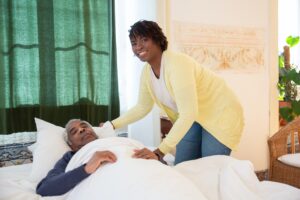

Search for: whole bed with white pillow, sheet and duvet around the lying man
xmin=0 ymin=119 xmax=300 ymax=200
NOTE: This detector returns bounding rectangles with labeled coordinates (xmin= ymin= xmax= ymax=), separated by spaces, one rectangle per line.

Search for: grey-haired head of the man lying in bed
xmin=67 ymin=120 xmax=97 ymax=151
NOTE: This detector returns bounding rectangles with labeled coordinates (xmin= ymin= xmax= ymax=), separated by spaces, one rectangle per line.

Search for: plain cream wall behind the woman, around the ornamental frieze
xmin=164 ymin=0 xmax=278 ymax=170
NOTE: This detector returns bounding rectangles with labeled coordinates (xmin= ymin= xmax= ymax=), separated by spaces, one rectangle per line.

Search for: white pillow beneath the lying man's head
xmin=29 ymin=118 xmax=116 ymax=182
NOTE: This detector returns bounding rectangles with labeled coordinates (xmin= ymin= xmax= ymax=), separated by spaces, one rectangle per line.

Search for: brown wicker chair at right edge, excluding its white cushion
xmin=268 ymin=117 xmax=300 ymax=188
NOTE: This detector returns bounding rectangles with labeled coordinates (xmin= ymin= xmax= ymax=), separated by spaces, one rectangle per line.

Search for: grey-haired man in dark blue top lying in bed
xmin=36 ymin=119 xmax=117 ymax=196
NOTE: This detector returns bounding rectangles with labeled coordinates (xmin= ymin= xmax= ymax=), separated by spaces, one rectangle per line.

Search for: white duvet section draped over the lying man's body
xmin=66 ymin=137 xmax=206 ymax=200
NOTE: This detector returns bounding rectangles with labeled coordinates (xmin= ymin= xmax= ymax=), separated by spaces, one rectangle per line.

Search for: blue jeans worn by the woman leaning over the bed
xmin=175 ymin=122 xmax=231 ymax=165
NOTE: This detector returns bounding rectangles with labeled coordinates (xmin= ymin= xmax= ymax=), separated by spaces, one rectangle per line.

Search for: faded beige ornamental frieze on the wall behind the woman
xmin=172 ymin=21 xmax=265 ymax=73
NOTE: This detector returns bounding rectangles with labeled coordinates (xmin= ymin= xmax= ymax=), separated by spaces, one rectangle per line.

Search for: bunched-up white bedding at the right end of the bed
xmin=174 ymin=155 xmax=300 ymax=200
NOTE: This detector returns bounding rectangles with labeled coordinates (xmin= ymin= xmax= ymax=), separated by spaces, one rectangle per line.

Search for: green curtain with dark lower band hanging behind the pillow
xmin=0 ymin=0 xmax=119 ymax=134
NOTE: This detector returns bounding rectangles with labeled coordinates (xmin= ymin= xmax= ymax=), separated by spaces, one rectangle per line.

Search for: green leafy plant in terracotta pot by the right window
xmin=278 ymin=36 xmax=300 ymax=125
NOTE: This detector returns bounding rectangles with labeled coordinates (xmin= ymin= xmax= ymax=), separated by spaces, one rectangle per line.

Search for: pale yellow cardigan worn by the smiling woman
xmin=112 ymin=51 xmax=244 ymax=154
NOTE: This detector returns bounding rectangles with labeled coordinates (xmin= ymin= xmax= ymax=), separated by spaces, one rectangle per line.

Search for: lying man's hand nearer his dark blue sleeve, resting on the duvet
xmin=84 ymin=151 xmax=117 ymax=174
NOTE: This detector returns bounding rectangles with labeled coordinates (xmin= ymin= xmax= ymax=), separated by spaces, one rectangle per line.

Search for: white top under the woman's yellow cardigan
xmin=151 ymin=62 xmax=178 ymax=112
